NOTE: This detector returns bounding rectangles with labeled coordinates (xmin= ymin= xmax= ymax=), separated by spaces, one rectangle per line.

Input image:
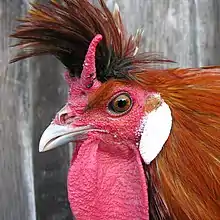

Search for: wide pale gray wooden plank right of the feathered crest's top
xmin=107 ymin=0 xmax=198 ymax=67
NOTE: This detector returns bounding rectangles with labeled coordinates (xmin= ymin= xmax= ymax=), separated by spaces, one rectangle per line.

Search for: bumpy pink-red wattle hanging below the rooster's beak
xmin=68 ymin=138 xmax=149 ymax=220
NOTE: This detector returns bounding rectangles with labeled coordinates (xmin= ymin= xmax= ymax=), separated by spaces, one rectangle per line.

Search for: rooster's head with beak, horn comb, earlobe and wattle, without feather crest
xmin=37 ymin=35 xmax=172 ymax=219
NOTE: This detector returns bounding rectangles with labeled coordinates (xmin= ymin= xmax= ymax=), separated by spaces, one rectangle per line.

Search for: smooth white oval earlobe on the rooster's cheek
xmin=139 ymin=102 xmax=172 ymax=164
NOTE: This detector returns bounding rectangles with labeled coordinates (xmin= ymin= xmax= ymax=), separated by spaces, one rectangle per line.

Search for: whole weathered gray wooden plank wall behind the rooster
xmin=0 ymin=0 xmax=220 ymax=220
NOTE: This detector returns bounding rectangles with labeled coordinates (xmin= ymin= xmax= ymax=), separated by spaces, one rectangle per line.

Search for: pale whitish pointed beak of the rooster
xmin=39 ymin=124 xmax=91 ymax=152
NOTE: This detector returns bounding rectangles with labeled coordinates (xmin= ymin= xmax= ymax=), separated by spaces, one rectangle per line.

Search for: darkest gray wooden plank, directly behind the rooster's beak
xmin=32 ymin=57 xmax=72 ymax=220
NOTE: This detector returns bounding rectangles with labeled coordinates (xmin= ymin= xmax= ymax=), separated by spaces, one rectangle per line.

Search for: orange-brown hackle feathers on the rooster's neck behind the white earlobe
xmin=135 ymin=67 xmax=220 ymax=220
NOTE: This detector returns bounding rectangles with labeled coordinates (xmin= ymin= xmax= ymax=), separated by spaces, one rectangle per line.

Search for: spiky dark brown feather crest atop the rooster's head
xmin=11 ymin=0 xmax=172 ymax=82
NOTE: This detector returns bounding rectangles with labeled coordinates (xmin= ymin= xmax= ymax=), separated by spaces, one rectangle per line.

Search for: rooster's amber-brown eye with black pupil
xmin=108 ymin=93 xmax=132 ymax=114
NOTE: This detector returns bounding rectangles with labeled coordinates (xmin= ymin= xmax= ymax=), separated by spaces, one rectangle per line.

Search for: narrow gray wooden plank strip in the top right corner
xmin=196 ymin=0 xmax=220 ymax=66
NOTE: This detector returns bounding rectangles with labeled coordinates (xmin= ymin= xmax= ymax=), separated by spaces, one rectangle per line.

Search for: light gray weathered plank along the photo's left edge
xmin=0 ymin=0 xmax=35 ymax=220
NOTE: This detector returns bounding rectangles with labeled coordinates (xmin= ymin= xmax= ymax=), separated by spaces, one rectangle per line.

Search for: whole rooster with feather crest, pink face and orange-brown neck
xmin=12 ymin=0 xmax=220 ymax=220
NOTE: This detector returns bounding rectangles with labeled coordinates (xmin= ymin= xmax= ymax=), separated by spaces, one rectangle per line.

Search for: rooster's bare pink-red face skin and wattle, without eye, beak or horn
xmin=58 ymin=80 xmax=153 ymax=220
